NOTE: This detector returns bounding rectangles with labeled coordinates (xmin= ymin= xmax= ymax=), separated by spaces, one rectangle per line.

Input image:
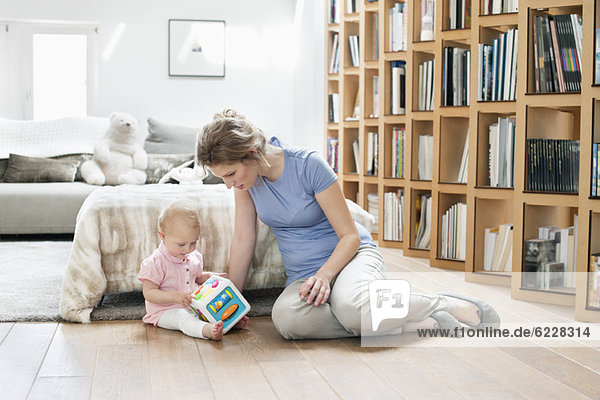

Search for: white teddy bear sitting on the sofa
xmin=81 ymin=112 xmax=148 ymax=185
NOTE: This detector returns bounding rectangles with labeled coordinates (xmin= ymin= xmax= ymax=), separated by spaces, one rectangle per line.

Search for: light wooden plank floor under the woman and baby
xmin=0 ymin=249 xmax=600 ymax=399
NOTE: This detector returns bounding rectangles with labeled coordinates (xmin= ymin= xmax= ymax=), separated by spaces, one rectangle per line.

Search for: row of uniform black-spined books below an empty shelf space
xmin=527 ymin=139 xmax=579 ymax=193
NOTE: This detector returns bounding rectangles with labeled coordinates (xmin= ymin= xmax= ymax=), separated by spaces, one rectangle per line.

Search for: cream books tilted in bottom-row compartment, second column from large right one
xmin=483 ymin=224 xmax=513 ymax=272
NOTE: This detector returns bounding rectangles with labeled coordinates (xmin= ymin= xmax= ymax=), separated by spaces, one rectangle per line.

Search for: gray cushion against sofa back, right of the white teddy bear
xmin=144 ymin=118 xmax=201 ymax=154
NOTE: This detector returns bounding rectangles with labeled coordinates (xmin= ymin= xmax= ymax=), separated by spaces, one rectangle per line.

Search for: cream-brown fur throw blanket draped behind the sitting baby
xmin=60 ymin=184 xmax=373 ymax=322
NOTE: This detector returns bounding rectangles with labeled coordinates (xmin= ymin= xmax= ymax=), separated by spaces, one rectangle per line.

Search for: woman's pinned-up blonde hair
xmin=196 ymin=109 xmax=268 ymax=167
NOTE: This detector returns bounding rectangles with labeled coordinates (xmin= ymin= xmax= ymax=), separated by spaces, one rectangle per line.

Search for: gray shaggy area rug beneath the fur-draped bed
xmin=0 ymin=241 xmax=283 ymax=322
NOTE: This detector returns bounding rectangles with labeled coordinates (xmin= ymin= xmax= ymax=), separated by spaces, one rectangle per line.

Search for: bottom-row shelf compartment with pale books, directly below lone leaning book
xmin=434 ymin=192 xmax=467 ymax=260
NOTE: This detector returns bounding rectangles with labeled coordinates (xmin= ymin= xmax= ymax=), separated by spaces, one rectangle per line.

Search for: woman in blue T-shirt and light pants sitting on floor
xmin=196 ymin=110 xmax=499 ymax=339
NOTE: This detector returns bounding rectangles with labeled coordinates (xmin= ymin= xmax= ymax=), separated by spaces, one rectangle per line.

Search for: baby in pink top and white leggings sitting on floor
xmin=138 ymin=201 xmax=248 ymax=340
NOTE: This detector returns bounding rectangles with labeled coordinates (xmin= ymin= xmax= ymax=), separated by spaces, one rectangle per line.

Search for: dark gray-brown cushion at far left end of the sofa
xmin=2 ymin=153 xmax=79 ymax=183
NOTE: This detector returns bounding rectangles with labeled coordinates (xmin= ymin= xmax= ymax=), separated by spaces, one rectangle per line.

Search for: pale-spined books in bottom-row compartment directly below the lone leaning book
xmin=440 ymin=203 xmax=467 ymax=260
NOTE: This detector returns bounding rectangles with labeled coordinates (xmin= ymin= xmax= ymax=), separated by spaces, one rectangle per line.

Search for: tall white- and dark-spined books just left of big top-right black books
xmin=477 ymin=29 xmax=519 ymax=101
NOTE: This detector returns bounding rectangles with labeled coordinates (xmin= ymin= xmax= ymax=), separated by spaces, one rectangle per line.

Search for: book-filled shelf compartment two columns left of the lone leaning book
xmin=383 ymin=124 xmax=408 ymax=179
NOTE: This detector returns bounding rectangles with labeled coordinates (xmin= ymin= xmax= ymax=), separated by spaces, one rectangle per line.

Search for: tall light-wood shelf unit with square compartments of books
xmin=325 ymin=0 xmax=600 ymax=322
